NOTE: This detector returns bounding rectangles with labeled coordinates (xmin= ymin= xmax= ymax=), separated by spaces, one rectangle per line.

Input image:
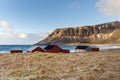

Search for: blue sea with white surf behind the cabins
xmin=0 ymin=45 xmax=120 ymax=53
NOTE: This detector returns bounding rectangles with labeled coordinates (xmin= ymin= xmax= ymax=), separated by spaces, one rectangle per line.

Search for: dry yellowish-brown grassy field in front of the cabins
xmin=0 ymin=50 xmax=120 ymax=80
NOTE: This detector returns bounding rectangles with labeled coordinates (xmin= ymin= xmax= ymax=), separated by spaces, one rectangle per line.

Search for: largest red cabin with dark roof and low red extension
xmin=44 ymin=45 xmax=69 ymax=53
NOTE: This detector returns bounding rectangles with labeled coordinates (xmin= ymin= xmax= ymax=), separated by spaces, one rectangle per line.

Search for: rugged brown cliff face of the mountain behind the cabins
xmin=37 ymin=21 xmax=120 ymax=44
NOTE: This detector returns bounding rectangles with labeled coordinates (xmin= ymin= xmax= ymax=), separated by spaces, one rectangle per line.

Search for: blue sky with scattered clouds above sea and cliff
xmin=0 ymin=0 xmax=120 ymax=45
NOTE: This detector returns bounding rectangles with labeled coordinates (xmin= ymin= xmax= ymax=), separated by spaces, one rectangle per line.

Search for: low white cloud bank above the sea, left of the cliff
xmin=0 ymin=31 xmax=50 ymax=44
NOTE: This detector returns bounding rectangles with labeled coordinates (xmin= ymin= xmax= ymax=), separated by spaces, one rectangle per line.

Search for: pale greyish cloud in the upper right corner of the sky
xmin=96 ymin=0 xmax=120 ymax=16
